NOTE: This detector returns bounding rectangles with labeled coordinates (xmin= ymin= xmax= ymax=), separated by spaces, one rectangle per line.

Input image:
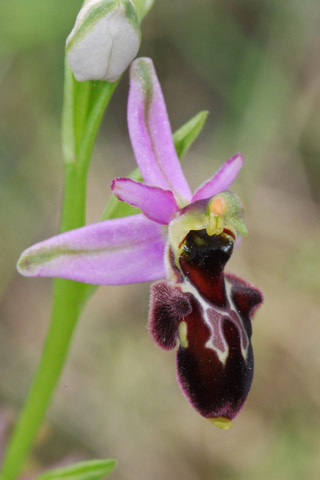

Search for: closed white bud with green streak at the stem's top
xmin=66 ymin=0 xmax=141 ymax=82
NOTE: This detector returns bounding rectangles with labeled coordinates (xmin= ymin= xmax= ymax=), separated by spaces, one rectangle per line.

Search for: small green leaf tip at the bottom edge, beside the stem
xmin=36 ymin=460 xmax=116 ymax=480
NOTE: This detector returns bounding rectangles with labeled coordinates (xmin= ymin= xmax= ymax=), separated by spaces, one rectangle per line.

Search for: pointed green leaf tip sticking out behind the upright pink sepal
xmin=173 ymin=110 xmax=209 ymax=160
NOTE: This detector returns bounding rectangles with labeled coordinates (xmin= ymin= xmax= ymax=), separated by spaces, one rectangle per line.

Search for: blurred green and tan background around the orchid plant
xmin=0 ymin=0 xmax=320 ymax=480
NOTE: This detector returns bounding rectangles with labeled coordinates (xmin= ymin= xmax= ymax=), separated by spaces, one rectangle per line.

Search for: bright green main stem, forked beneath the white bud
xmin=1 ymin=64 xmax=118 ymax=480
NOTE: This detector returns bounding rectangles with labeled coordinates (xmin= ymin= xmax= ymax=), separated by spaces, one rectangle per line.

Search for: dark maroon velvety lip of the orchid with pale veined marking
xmin=149 ymin=230 xmax=263 ymax=428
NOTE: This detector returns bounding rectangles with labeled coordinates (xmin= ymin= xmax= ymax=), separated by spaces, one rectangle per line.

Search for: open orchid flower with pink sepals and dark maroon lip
xmin=18 ymin=58 xmax=263 ymax=428
